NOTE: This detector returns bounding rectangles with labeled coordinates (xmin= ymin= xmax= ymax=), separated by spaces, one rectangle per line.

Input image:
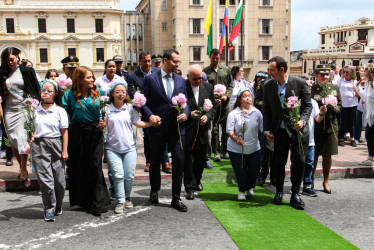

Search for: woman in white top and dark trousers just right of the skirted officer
xmin=338 ymin=65 xmax=359 ymax=147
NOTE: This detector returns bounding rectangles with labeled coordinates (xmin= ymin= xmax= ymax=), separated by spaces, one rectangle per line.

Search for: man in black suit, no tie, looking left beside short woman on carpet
xmin=262 ymin=56 xmax=312 ymax=209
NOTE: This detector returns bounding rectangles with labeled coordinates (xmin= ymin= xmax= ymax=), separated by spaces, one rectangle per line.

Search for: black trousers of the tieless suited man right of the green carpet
xmin=274 ymin=128 xmax=309 ymax=194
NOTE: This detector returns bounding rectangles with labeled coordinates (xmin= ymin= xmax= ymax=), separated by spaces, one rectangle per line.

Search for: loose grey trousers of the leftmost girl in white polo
xmin=32 ymin=137 xmax=66 ymax=213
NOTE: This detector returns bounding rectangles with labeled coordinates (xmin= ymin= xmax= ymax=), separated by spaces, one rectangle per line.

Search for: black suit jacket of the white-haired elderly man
xmin=185 ymin=80 xmax=216 ymax=146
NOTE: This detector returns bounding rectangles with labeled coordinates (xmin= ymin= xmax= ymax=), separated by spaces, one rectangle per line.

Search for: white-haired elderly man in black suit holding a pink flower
xmin=184 ymin=64 xmax=216 ymax=200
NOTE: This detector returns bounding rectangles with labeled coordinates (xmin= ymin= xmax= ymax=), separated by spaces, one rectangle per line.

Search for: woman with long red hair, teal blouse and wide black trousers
xmin=62 ymin=66 xmax=110 ymax=216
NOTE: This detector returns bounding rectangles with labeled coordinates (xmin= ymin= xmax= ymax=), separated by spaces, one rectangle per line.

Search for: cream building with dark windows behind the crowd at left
xmin=0 ymin=0 xmax=124 ymax=78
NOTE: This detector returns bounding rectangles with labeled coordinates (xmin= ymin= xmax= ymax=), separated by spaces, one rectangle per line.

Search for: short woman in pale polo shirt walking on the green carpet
xmin=226 ymin=88 xmax=262 ymax=200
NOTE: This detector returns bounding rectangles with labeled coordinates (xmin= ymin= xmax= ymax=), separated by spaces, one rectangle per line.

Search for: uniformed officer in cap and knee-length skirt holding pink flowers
xmin=311 ymin=64 xmax=342 ymax=194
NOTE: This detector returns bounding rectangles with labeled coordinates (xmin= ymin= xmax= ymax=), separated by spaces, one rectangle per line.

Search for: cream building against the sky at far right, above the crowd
xmin=302 ymin=17 xmax=374 ymax=77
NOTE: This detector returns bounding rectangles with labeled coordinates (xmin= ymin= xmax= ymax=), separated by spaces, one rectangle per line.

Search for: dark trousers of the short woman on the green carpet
xmin=228 ymin=150 xmax=261 ymax=192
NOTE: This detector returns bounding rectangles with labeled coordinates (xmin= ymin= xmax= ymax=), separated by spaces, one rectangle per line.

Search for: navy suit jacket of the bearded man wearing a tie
xmin=141 ymin=70 xmax=190 ymax=135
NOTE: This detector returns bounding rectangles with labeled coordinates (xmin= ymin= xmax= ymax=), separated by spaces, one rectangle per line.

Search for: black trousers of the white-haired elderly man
xmin=184 ymin=140 xmax=208 ymax=191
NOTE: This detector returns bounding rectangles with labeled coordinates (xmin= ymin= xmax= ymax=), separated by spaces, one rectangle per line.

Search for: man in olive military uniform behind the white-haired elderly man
xmin=203 ymin=49 xmax=233 ymax=161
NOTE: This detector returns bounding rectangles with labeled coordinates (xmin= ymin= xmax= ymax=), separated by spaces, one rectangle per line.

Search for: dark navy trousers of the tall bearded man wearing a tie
xmin=148 ymin=133 xmax=185 ymax=199
